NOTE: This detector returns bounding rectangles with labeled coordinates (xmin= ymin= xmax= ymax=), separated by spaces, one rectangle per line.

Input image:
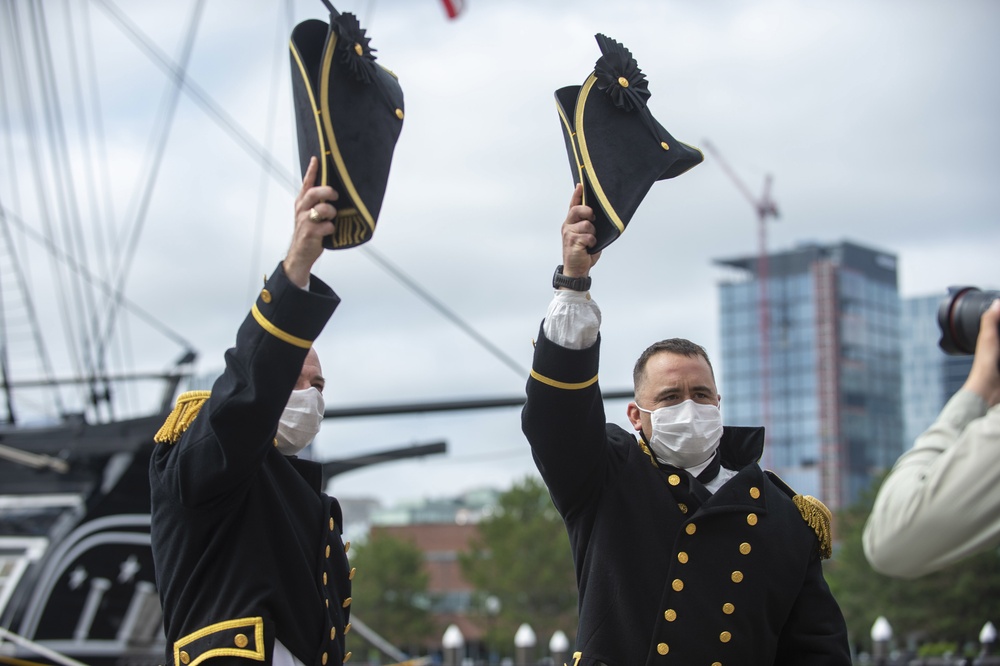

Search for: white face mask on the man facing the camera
xmin=636 ymin=400 xmax=722 ymax=469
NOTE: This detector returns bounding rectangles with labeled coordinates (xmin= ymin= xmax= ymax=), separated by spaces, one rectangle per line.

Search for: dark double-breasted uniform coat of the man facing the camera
xmin=522 ymin=332 xmax=851 ymax=666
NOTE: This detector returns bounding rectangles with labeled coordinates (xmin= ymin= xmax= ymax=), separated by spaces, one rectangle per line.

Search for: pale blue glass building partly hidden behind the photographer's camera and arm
xmin=900 ymin=291 xmax=972 ymax=448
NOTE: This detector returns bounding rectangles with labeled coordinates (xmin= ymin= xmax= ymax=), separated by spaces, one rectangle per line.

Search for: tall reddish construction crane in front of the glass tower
xmin=702 ymin=139 xmax=779 ymax=467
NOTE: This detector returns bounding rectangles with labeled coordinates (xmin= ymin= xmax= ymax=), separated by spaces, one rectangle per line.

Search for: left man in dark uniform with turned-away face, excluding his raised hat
xmin=149 ymin=159 xmax=353 ymax=666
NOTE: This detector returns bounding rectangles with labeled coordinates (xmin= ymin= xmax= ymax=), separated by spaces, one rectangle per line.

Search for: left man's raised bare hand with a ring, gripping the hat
xmin=283 ymin=157 xmax=339 ymax=289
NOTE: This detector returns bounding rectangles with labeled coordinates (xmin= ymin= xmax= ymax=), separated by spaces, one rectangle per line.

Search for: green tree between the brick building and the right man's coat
xmin=459 ymin=476 xmax=577 ymax=651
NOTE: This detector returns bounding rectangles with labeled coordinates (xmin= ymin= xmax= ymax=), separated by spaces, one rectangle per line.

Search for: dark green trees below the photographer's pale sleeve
xmin=826 ymin=472 xmax=1000 ymax=649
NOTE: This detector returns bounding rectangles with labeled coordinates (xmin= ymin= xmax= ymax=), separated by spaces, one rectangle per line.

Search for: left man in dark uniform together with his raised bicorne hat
xmin=149 ymin=0 xmax=403 ymax=666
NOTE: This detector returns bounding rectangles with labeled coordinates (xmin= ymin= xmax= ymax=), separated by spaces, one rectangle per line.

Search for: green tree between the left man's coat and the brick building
xmin=351 ymin=530 xmax=433 ymax=654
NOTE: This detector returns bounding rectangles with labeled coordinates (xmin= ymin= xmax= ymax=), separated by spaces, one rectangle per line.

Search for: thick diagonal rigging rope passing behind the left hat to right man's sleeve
xmin=95 ymin=0 xmax=528 ymax=377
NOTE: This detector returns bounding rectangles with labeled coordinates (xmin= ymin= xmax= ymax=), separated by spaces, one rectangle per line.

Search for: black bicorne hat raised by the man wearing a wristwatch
xmin=556 ymin=34 xmax=704 ymax=254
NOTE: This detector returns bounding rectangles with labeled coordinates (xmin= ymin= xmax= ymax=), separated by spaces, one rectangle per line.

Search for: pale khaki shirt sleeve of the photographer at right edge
xmin=863 ymin=390 xmax=1000 ymax=578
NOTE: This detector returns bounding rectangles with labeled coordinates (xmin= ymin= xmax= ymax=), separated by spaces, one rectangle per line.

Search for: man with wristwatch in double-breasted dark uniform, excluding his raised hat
xmin=522 ymin=186 xmax=851 ymax=666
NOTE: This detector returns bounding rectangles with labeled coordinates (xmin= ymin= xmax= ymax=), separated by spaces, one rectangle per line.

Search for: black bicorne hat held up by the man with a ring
xmin=289 ymin=0 xmax=403 ymax=249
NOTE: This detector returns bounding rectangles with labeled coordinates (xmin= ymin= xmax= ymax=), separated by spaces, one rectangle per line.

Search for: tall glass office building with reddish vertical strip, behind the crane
xmin=715 ymin=242 xmax=904 ymax=509
